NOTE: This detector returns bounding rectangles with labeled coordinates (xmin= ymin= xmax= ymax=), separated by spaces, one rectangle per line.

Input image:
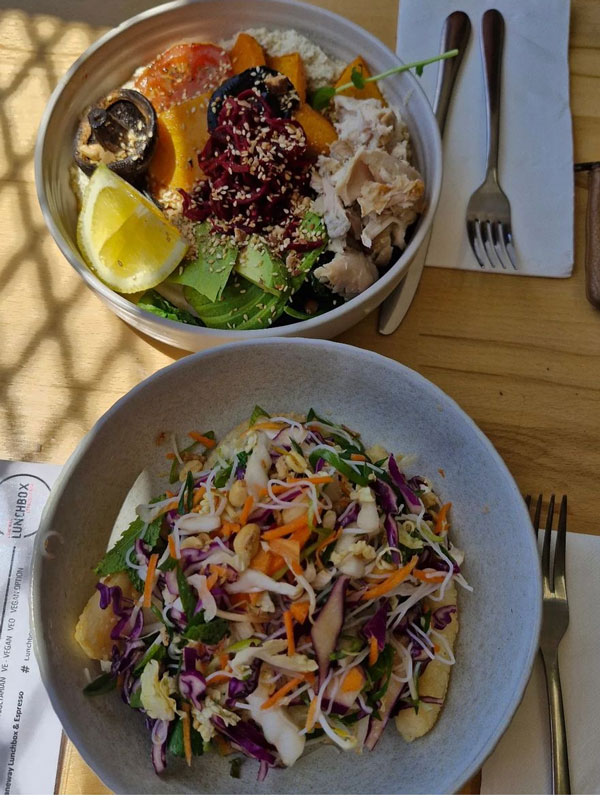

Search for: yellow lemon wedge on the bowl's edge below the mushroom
xmin=77 ymin=164 xmax=188 ymax=294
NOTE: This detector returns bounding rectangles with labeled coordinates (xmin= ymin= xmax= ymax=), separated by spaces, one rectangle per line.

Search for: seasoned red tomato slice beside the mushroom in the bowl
xmin=135 ymin=43 xmax=232 ymax=111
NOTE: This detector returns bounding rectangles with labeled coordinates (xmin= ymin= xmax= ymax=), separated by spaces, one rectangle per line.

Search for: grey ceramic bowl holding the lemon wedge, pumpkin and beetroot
xmin=35 ymin=0 xmax=442 ymax=351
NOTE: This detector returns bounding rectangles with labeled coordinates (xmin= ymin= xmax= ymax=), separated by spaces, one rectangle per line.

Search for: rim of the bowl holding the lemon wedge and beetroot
xmin=34 ymin=0 xmax=442 ymax=340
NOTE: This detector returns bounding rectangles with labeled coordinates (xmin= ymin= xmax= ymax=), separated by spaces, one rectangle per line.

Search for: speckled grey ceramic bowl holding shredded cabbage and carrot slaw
xmin=32 ymin=339 xmax=541 ymax=794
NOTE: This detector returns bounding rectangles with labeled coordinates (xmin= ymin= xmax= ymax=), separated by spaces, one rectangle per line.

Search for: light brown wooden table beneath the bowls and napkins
xmin=0 ymin=0 xmax=600 ymax=794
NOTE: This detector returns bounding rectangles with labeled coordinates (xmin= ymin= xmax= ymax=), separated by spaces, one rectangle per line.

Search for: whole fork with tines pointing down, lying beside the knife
xmin=467 ymin=9 xmax=517 ymax=270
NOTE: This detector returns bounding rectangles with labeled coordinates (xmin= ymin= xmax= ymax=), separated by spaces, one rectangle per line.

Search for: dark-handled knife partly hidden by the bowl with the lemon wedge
xmin=379 ymin=11 xmax=471 ymax=336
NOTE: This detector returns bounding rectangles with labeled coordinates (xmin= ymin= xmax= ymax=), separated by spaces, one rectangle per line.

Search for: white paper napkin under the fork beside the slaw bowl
xmin=481 ymin=534 xmax=600 ymax=794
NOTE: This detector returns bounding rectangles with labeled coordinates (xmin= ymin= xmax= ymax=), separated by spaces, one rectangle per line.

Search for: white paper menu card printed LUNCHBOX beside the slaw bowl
xmin=0 ymin=461 xmax=62 ymax=794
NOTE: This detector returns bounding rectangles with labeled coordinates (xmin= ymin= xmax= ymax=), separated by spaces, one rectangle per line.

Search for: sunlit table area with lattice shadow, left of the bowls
xmin=0 ymin=0 xmax=188 ymax=460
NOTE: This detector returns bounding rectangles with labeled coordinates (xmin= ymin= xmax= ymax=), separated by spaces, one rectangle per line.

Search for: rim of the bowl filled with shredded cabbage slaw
xmin=29 ymin=336 xmax=542 ymax=794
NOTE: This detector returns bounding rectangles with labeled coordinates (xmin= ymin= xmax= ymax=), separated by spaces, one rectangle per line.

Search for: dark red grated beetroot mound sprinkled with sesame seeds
xmin=180 ymin=89 xmax=315 ymax=236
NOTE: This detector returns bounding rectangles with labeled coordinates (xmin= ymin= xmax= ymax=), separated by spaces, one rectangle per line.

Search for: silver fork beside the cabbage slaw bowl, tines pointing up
xmin=525 ymin=495 xmax=571 ymax=794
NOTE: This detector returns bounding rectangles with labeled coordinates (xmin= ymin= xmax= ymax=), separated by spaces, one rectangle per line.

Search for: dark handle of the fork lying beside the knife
xmin=481 ymin=9 xmax=504 ymax=180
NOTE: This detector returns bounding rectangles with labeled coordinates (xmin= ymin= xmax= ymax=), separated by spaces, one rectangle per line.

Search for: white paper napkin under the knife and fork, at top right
xmin=396 ymin=0 xmax=574 ymax=278
